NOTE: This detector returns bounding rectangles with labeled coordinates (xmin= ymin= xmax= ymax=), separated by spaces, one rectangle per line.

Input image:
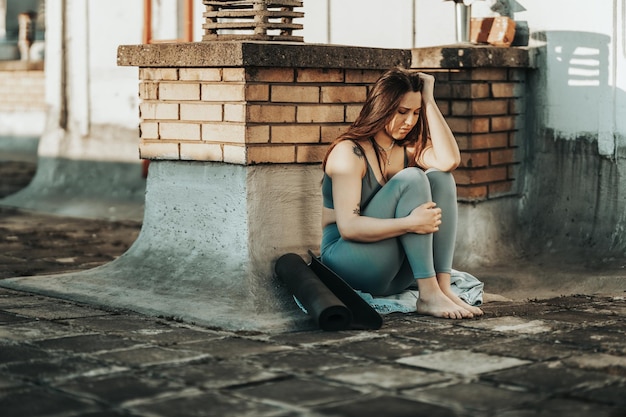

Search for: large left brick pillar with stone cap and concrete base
xmin=112 ymin=41 xmax=410 ymax=329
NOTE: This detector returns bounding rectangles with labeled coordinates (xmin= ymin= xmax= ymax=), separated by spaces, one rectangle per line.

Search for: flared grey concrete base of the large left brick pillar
xmin=1 ymin=161 xmax=321 ymax=331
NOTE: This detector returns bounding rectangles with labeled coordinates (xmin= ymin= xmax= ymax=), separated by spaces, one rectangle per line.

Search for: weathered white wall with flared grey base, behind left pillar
xmin=2 ymin=1 xmax=145 ymax=220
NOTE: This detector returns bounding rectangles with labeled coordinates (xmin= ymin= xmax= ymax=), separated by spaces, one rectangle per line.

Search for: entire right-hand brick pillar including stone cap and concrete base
xmin=411 ymin=45 xmax=534 ymax=271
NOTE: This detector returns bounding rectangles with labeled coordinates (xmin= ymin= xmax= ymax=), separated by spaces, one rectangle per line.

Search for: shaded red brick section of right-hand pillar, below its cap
xmin=431 ymin=68 xmax=525 ymax=201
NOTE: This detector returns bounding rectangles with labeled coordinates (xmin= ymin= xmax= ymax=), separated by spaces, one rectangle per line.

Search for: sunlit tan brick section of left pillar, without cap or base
xmin=140 ymin=67 xmax=382 ymax=164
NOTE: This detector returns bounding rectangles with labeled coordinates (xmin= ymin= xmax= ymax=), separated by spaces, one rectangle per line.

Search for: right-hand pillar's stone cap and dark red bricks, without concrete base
xmin=413 ymin=46 xmax=532 ymax=202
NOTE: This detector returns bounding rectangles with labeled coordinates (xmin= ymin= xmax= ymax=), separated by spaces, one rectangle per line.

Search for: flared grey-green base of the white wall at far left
xmin=0 ymin=125 xmax=146 ymax=221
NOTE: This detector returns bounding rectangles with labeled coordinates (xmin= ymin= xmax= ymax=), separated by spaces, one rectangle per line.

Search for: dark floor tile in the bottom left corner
xmin=0 ymin=388 xmax=100 ymax=417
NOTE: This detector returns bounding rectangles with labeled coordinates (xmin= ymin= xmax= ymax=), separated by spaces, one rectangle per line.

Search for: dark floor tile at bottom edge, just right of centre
xmin=314 ymin=395 xmax=459 ymax=417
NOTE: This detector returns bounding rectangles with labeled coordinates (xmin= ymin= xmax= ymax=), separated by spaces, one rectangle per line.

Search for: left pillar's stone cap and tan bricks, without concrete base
xmin=119 ymin=43 xmax=408 ymax=165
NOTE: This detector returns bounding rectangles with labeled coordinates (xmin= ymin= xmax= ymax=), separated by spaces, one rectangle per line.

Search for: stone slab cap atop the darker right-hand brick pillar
xmin=411 ymin=45 xmax=537 ymax=69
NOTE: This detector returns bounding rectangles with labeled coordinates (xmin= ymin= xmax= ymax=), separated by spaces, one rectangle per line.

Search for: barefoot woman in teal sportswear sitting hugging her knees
xmin=321 ymin=68 xmax=483 ymax=319
